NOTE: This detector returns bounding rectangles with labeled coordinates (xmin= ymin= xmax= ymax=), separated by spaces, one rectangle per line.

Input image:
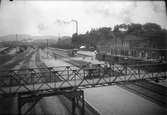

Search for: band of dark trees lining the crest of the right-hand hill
xmin=72 ymin=23 xmax=167 ymax=49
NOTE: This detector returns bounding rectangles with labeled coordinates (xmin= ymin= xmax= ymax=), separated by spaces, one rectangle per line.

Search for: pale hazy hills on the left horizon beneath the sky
xmin=0 ymin=34 xmax=70 ymax=47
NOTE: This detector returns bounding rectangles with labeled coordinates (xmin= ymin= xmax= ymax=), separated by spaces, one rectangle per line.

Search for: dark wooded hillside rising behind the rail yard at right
xmin=72 ymin=23 xmax=167 ymax=49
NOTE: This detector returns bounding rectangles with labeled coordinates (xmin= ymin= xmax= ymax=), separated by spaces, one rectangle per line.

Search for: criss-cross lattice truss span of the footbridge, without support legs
xmin=0 ymin=64 xmax=167 ymax=95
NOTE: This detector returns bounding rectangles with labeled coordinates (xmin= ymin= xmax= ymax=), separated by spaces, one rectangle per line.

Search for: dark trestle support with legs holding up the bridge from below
xmin=17 ymin=90 xmax=85 ymax=115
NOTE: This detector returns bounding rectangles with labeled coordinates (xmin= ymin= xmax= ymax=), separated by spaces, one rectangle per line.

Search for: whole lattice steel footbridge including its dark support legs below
xmin=0 ymin=63 xmax=167 ymax=115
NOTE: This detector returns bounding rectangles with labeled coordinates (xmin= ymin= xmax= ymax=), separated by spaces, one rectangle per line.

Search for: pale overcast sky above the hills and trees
xmin=0 ymin=0 xmax=167 ymax=36
